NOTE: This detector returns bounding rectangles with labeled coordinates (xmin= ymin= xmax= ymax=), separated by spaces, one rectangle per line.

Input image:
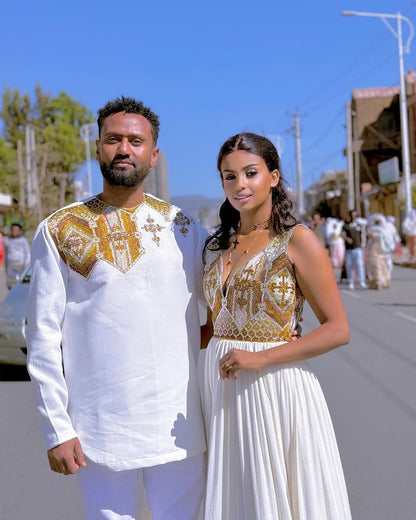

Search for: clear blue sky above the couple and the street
xmin=0 ymin=0 xmax=416 ymax=197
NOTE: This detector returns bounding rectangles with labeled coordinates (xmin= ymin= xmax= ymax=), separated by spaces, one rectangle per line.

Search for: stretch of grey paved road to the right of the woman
xmin=305 ymin=267 xmax=416 ymax=520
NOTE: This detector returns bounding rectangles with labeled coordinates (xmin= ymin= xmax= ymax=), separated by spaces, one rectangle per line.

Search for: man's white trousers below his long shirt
xmin=77 ymin=455 xmax=205 ymax=520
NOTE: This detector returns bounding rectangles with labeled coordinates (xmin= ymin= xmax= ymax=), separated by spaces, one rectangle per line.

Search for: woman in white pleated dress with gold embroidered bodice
xmin=199 ymin=133 xmax=351 ymax=520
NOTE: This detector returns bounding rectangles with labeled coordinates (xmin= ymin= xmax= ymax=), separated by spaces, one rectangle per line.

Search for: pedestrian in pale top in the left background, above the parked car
xmin=4 ymin=222 xmax=30 ymax=289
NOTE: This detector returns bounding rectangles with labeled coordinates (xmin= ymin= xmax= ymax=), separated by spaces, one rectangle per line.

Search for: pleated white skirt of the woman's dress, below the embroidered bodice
xmin=199 ymin=338 xmax=351 ymax=520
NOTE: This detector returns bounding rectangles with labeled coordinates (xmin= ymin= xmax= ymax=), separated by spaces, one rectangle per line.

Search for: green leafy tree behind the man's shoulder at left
xmin=0 ymin=86 xmax=94 ymax=228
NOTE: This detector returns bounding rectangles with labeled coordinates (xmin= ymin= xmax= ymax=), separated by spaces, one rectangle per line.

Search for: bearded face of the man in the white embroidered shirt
xmin=96 ymin=112 xmax=159 ymax=188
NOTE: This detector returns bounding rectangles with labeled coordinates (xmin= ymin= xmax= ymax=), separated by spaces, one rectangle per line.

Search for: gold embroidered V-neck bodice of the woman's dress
xmin=204 ymin=230 xmax=304 ymax=342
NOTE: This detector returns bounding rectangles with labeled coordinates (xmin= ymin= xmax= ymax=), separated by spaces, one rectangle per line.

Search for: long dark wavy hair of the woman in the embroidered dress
xmin=205 ymin=132 xmax=298 ymax=249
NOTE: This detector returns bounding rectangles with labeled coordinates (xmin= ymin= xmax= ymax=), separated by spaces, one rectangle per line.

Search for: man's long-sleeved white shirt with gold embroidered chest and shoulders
xmin=27 ymin=196 xmax=206 ymax=470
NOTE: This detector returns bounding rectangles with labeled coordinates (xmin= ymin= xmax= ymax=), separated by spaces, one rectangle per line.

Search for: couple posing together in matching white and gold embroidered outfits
xmin=27 ymin=97 xmax=350 ymax=520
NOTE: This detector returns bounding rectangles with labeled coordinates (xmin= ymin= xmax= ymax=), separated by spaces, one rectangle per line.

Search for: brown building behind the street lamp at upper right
xmin=351 ymin=71 xmax=416 ymax=221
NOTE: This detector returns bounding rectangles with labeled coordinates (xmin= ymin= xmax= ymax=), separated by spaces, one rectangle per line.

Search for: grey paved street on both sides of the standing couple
xmin=0 ymin=266 xmax=416 ymax=520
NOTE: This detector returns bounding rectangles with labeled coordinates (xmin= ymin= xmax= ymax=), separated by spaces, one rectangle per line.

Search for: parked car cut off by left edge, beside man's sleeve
xmin=0 ymin=266 xmax=31 ymax=365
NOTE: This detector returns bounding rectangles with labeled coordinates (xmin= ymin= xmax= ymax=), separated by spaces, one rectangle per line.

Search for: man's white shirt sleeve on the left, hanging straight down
xmin=26 ymin=222 xmax=77 ymax=449
